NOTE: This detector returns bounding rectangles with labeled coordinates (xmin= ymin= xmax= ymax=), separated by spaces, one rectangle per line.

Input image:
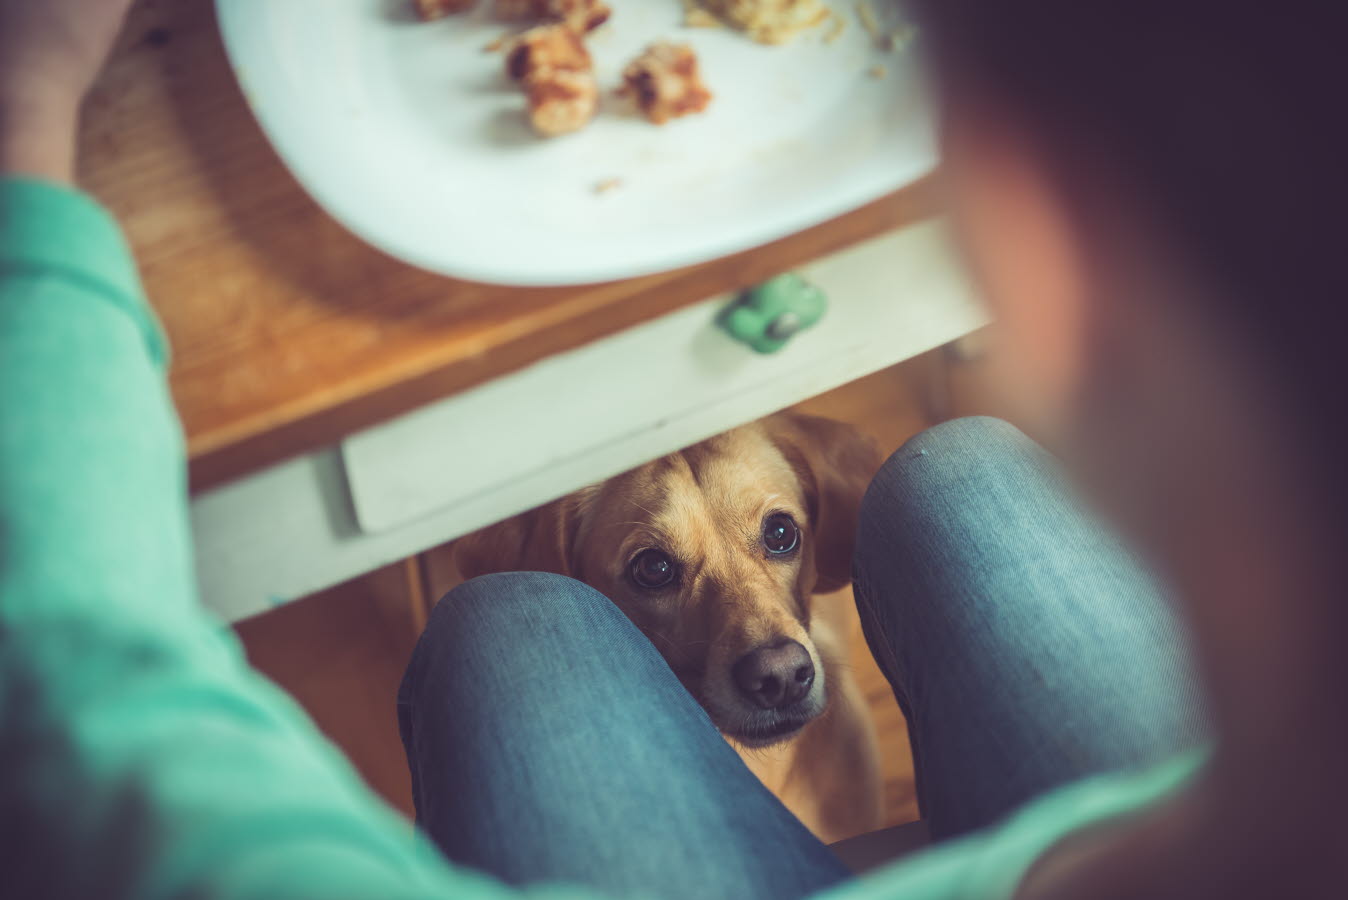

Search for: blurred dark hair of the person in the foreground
xmin=907 ymin=0 xmax=1348 ymax=505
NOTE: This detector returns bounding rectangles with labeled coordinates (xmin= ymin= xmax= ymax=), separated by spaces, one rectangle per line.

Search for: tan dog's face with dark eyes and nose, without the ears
xmin=574 ymin=428 xmax=828 ymax=745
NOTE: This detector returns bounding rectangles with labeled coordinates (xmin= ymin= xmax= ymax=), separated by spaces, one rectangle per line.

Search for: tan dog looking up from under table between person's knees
xmin=454 ymin=412 xmax=882 ymax=841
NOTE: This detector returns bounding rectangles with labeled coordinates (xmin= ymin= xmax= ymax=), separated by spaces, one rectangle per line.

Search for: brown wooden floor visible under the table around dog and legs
xmin=237 ymin=339 xmax=1000 ymax=825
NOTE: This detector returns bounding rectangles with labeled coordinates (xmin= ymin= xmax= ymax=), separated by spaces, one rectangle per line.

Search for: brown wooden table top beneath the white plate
xmin=80 ymin=0 xmax=938 ymax=490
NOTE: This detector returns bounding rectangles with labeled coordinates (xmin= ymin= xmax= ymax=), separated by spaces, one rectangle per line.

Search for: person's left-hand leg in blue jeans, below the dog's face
xmin=398 ymin=573 xmax=847 ymax=897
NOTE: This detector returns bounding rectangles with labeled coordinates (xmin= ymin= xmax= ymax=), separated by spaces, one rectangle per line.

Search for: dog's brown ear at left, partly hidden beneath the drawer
xmin=454 ymin=494 xmax=581 ymax=579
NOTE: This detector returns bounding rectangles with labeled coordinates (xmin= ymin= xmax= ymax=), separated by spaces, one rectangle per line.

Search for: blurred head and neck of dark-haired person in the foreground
xmin=909 ymin=0 xmax=1348 ymax=862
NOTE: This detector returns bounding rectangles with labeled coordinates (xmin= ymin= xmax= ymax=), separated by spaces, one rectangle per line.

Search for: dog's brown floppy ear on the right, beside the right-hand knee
xmin=763 ymin=412 xmax=883 ymax=594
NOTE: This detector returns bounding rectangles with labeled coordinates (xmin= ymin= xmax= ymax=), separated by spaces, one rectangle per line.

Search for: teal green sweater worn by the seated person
xmin=0 ymin=181 xmax=1193 ymax=900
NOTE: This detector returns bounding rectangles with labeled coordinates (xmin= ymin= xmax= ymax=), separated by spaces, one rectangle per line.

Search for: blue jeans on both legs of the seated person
xmin=398 ymin=419 xmax=1200 ymax=897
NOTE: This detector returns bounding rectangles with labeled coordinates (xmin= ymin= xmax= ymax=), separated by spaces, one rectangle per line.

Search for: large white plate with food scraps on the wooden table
xmin=217 ymin=0 xmax=936 ymax=284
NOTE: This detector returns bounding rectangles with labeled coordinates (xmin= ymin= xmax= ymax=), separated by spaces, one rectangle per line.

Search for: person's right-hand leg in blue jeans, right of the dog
xmin=855 ymin=418 xmax=1202 ymax=838
